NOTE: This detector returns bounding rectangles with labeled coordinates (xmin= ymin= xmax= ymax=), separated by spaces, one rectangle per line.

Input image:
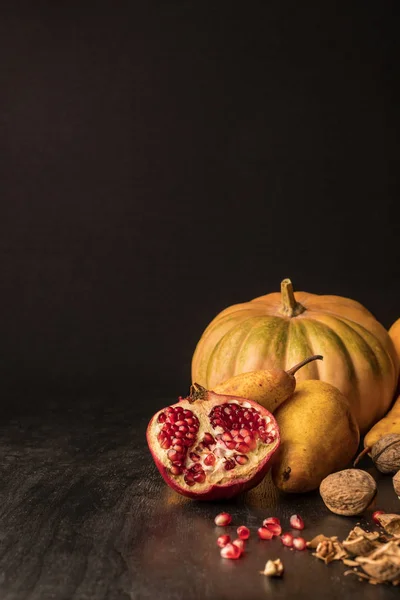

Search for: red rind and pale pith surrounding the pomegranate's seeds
xmin=146 ymin=390 xmax=280 ymax=501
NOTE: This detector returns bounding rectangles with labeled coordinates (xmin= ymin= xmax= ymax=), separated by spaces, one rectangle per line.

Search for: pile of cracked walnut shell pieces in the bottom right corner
xmin=307 ymin=514 xmax=400 ymax=585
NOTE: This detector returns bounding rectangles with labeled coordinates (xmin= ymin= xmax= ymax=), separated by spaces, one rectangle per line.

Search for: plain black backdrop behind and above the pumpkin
xmin=0 ymin=0 xmax=400 ymax=402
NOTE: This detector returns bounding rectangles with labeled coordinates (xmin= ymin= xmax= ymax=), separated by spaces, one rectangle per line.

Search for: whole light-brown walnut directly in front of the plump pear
xmin=319 ymin=469 xmax=377 ymax=517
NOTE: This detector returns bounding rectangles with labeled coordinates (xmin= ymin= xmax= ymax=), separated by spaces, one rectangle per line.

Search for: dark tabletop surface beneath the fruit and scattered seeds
xmin=0 ymin=398 xmax=400 ymax=600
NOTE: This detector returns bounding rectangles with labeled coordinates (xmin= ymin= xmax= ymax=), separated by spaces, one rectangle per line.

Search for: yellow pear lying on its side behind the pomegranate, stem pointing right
xmin=213 ymin=354 xmax=323 ymax=413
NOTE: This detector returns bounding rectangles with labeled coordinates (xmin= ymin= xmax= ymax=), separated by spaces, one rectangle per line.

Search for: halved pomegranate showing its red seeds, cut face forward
xmin=147 ymin=384 xmax=280 ymax=500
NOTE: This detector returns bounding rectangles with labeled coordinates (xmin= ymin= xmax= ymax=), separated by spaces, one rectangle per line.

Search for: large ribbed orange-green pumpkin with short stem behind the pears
xmin=192 ymin=279 xmax=399 ymax=433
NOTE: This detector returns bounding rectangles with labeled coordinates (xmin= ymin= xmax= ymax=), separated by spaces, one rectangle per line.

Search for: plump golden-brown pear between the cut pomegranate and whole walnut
xmin=272 ymin=379 xmax=360 ymax=493
